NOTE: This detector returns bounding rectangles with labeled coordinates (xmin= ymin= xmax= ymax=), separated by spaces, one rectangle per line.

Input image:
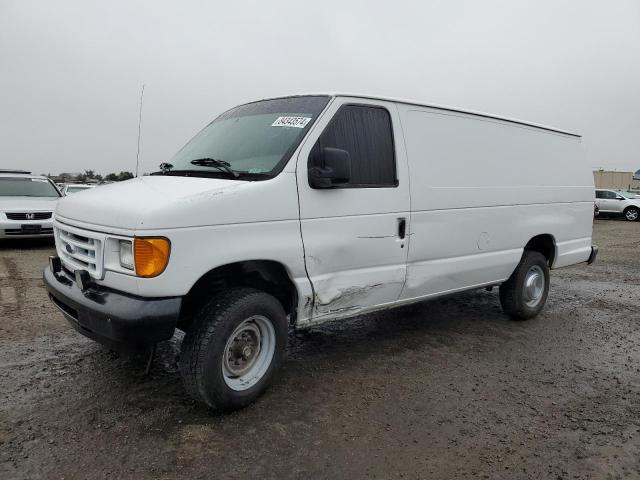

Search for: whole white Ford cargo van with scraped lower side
xmin=44 ymin=94 xmax=597 ymax=409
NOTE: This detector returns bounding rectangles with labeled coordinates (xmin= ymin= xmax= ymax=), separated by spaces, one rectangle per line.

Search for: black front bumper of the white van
xmin=43 ymin=260 xmax=182 ymax=350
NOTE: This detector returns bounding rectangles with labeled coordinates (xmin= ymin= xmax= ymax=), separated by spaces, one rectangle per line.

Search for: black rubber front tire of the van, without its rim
xmin=180 ymin=288 xmax=288 ymax=410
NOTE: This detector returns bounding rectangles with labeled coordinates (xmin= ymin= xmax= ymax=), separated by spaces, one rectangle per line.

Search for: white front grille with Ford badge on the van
xmin=55 ymin=224 xmax=102 ymax=278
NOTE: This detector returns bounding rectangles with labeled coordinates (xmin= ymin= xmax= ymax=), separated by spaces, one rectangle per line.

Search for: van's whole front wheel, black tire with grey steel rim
xmin=180 ymin=288 xmax=288 ymax=410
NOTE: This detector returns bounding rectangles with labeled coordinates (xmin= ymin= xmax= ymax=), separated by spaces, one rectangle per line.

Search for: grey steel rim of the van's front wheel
xmin=222 ymin=315 xmax=276 ymax=391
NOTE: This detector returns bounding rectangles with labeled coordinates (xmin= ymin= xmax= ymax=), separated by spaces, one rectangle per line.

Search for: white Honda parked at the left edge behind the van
xmin=0 ymin=170 xmax=60 ymax=239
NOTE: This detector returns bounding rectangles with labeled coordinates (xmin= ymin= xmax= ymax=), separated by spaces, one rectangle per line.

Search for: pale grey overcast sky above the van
xmin=0 ymin=0 xmax=640 ymax=174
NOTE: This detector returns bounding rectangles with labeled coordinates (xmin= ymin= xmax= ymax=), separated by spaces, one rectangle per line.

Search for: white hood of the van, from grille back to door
xmin=56 ymin=172 xmax=298 ymax=234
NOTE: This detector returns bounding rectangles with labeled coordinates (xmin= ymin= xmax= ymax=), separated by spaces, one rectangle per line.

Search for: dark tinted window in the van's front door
xmin=309 ymin=105 xmax=398 ymax=187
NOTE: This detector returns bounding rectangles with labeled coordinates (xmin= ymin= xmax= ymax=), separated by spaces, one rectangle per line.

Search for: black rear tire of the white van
xmin=500 ymin=250 xmax=549 ymax=320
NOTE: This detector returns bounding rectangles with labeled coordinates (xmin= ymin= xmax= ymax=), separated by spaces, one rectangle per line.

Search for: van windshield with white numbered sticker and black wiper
xmin=169 ymin=96 xmax=329 ymax=179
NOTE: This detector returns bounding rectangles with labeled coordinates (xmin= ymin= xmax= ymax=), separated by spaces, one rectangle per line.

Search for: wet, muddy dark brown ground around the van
xmin=0 ymin=220 xmax=640 ymax=479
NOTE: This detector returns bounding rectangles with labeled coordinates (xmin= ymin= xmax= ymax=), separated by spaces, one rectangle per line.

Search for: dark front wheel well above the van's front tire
xmin=178 ymin=260 xmax=298 ymax=330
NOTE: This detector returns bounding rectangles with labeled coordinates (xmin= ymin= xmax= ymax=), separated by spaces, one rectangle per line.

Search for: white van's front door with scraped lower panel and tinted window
xmin=296 ymin=97 xmax=410 ymax=321
